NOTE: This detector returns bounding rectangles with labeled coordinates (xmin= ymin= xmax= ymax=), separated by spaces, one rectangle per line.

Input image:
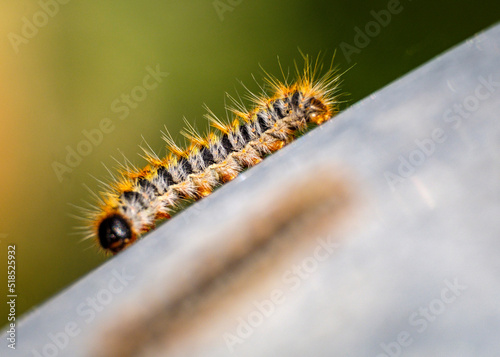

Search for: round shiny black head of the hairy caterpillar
xmin=97 ymin=213 xmax=137 ymax=254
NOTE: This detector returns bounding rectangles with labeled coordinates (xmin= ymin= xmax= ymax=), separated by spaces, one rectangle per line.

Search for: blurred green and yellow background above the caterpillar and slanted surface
xmin=0 ymin=0 xmax=500 ymax=325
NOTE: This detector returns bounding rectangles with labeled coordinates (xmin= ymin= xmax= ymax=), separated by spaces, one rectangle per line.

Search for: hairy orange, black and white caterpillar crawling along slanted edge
xmin=80 ymin=56 xmax=340 ymax=254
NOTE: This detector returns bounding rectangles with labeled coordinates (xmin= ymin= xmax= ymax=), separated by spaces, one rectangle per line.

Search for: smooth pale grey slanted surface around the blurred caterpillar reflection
xmin=0 ymin=25 xmax=500 ymax=356
